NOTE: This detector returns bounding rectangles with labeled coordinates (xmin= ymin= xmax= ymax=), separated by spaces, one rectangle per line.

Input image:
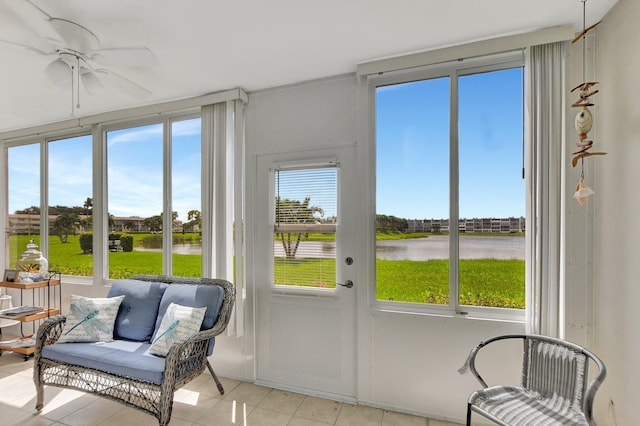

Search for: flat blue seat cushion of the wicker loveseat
xmin=42 ymin=340 xmax=165 ymax=385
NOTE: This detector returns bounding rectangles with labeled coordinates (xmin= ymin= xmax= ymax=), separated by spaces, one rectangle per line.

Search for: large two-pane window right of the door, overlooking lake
xmin=374 ymin=57 xmax=525 ymax=315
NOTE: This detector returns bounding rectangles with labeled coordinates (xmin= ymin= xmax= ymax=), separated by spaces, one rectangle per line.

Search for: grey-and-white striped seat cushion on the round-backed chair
xmin=469 ymin=386 xmax=588 ymax=426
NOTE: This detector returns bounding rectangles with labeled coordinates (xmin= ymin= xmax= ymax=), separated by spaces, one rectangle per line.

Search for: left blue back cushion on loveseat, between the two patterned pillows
xmin=108 ymin=280 xmax=168 ymax=342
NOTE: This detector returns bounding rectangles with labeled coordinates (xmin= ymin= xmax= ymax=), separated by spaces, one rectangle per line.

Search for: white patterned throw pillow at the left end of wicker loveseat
xmin=57 ymin=294 xmax=124 ymax=343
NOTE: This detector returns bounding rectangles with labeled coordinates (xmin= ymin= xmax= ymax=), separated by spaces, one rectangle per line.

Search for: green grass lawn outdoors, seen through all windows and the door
xmin=10 ymin=234 xmax=525 ymax=309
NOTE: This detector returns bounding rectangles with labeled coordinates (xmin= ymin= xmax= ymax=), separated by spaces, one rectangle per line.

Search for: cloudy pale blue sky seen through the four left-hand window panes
xmin=9 ymin=119 xmax=201 ymax=222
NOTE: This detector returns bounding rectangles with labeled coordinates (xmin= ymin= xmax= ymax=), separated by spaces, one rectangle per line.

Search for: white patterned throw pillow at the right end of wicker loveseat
xmin=149 ymin=303 xmax=207 ymax=356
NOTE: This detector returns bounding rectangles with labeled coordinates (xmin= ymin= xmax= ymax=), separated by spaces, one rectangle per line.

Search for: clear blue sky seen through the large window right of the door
xmin=376 ymin=68 xmax=525 ymax=219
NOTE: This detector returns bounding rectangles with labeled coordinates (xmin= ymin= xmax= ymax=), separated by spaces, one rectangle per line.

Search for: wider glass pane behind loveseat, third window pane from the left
xmin=107 ymin=124 xmax=164 ymax=278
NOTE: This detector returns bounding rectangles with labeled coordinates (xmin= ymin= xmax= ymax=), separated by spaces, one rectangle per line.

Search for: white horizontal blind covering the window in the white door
xmin=272 ymin=164 xmax=338 ymax=288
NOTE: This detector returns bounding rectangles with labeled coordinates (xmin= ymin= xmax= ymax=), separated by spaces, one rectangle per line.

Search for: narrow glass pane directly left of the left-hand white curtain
xmin=171 ymin=118 xmax=202 ymax=276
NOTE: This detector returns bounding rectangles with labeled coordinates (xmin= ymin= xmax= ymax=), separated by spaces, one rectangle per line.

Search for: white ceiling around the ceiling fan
xmin=0 ymin=0 xmax=616 ymax=131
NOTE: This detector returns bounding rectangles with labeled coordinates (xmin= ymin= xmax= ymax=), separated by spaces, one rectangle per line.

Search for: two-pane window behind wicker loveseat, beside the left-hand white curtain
xmin=106 ymin=118 xmax=202 ymax=278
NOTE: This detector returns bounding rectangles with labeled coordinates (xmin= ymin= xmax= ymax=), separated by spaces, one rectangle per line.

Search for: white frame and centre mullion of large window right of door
xmin=366 ymin=50 xmax=534 ymax=322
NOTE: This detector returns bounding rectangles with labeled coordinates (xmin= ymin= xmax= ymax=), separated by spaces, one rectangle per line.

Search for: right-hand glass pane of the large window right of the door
xmin=458 ymin=68 xmax=525 ymax=308
